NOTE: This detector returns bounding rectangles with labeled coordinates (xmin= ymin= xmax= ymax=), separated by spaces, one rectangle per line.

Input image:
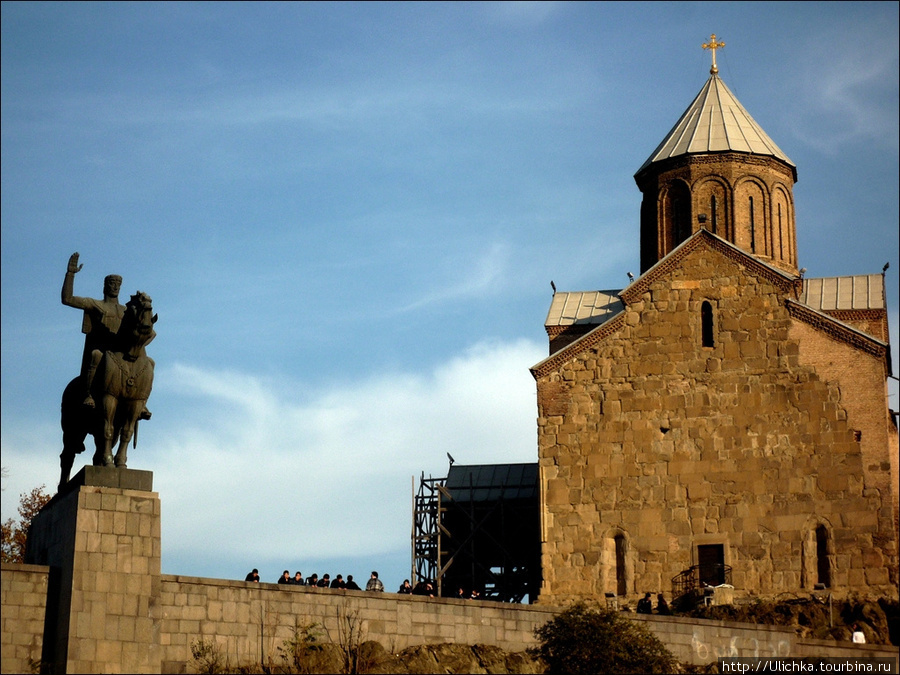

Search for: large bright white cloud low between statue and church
xmin=144 ymin=341 xmax=544 ymax=560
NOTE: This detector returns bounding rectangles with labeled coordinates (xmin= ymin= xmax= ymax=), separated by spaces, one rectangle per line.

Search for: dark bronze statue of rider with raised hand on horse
xmin=59 ymin=253 xmax=158 ymax=489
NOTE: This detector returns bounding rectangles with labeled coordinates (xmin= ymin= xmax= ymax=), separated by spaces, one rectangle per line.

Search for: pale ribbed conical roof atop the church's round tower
xmin=637 ymin=72 xmax=796 ymax=174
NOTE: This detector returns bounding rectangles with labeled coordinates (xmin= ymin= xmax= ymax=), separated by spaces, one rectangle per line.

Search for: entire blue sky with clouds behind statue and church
xmin=0 ymin=2 xmax=900 ymax=589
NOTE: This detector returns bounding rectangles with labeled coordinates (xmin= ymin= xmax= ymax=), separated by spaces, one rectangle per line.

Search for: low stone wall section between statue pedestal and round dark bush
xmin=157 ymin=576 xmax=554 ymax=672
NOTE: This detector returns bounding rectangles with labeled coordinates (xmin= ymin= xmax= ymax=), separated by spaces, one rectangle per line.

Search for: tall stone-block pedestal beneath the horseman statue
xmin=26 ymin=466 xmax=160 ymax=673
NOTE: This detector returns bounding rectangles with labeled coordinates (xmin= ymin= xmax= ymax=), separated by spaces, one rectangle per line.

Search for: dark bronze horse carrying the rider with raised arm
xmin=59 ymin=291 xmax=159 ymax=488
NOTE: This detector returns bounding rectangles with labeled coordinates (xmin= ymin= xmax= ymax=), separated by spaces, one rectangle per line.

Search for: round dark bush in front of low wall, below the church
xmin=530 ymin=603 xmax=676 ymax=675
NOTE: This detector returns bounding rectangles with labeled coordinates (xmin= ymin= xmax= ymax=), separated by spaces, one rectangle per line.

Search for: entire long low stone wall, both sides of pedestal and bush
xmin=0 ymin=563 xmax=897 ymax=673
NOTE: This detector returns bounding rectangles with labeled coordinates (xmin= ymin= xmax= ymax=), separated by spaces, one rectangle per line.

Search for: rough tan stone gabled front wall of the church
xmin=534 ymin=237 xmax=897 ymax=604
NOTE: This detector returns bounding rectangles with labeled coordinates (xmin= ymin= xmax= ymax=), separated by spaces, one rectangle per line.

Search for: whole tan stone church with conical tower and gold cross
xmin=532 ymin=35 xmax=898 ymax=604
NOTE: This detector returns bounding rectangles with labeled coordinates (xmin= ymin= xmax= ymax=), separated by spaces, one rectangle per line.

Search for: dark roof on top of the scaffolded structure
xmin=444 ymin=463 xmax=538 ymax=502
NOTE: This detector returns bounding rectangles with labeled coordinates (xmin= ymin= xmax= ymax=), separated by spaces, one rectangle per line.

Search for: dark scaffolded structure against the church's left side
xmin=412 ymin=464 xmax=541 ymax=602
